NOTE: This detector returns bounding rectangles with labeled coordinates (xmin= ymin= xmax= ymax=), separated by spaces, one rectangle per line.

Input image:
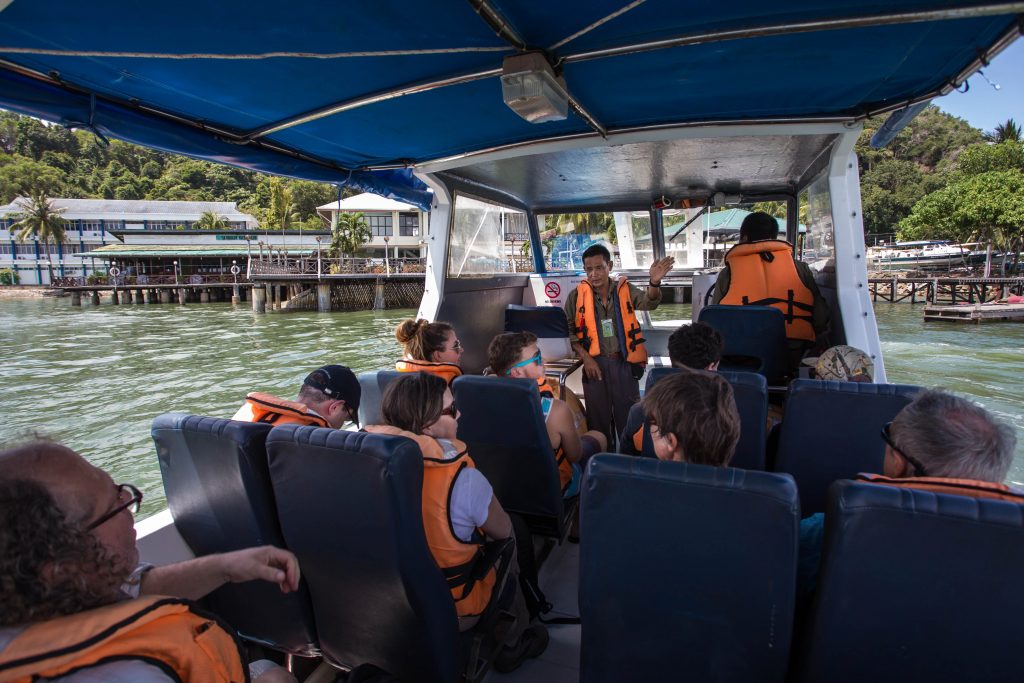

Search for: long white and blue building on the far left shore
xmin=0 ymin=199 xmax=260 ymax=285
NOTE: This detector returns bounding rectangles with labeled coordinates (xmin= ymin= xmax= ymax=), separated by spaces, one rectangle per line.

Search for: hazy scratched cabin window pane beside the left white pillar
xmin=449 ymin=195 xmax=532 ymax=278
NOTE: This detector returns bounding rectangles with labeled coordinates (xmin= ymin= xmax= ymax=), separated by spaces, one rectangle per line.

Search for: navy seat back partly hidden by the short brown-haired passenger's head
xmin=643 ymin=368 xmax=768 ymax=470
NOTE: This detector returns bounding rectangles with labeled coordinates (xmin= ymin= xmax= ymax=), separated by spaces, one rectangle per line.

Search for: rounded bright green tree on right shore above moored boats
xmin=897 ymin=169 xmax=1024 ymax=250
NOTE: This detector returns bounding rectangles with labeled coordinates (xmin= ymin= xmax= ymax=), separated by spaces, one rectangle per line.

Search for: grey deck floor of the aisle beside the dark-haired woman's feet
xmin=483 ymin=542 xmax=580 ymax=683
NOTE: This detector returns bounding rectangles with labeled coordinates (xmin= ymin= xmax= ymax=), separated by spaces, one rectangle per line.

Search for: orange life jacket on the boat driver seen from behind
xmin=719 ymin=240 xmax=816 ymax=341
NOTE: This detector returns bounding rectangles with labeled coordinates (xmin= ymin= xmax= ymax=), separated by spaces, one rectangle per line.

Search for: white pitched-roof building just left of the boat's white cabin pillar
xmin=316 ymin=193 xmax=428 ymax=258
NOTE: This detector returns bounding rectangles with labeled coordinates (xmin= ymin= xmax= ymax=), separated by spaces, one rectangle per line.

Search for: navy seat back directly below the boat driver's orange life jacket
xmin=697 ymin=305 xmax=788 ymax=383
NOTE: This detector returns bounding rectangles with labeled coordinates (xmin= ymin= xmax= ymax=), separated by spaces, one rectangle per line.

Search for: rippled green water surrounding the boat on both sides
xmin=0 ymin=299 xmax=1024 ymax=515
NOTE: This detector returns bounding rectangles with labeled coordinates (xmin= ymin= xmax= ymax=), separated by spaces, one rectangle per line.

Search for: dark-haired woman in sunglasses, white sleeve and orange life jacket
xmin=366 ymin=373 xmax=548 ymax=672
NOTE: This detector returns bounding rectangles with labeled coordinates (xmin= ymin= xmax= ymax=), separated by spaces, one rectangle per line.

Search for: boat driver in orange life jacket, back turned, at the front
xmin=712 ymin=211 xmax=828 ymax=349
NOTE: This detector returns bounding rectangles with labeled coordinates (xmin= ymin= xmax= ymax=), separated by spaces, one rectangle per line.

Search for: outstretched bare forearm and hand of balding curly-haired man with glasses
xmin=139 ymin=546 xmax=299 ymax=600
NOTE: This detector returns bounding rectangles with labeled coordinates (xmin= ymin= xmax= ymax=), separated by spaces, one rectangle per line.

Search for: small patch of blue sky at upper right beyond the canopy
xmin=933 ymin=38 xmax=1024 ymax=131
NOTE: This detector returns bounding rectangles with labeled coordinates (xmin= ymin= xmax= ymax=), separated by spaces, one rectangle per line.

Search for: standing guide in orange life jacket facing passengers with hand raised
xmin=565 ymin=245 xmax=675 ymax=443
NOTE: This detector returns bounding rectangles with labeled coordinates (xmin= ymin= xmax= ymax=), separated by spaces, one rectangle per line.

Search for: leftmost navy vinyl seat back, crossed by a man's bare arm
xmin=152 ymin=413 xmax=317 ymax=655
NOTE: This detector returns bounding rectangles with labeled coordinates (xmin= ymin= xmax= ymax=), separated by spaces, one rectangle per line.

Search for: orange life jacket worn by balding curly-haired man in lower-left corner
xmin=0 ymin=596 xmax=249 ymax=683
